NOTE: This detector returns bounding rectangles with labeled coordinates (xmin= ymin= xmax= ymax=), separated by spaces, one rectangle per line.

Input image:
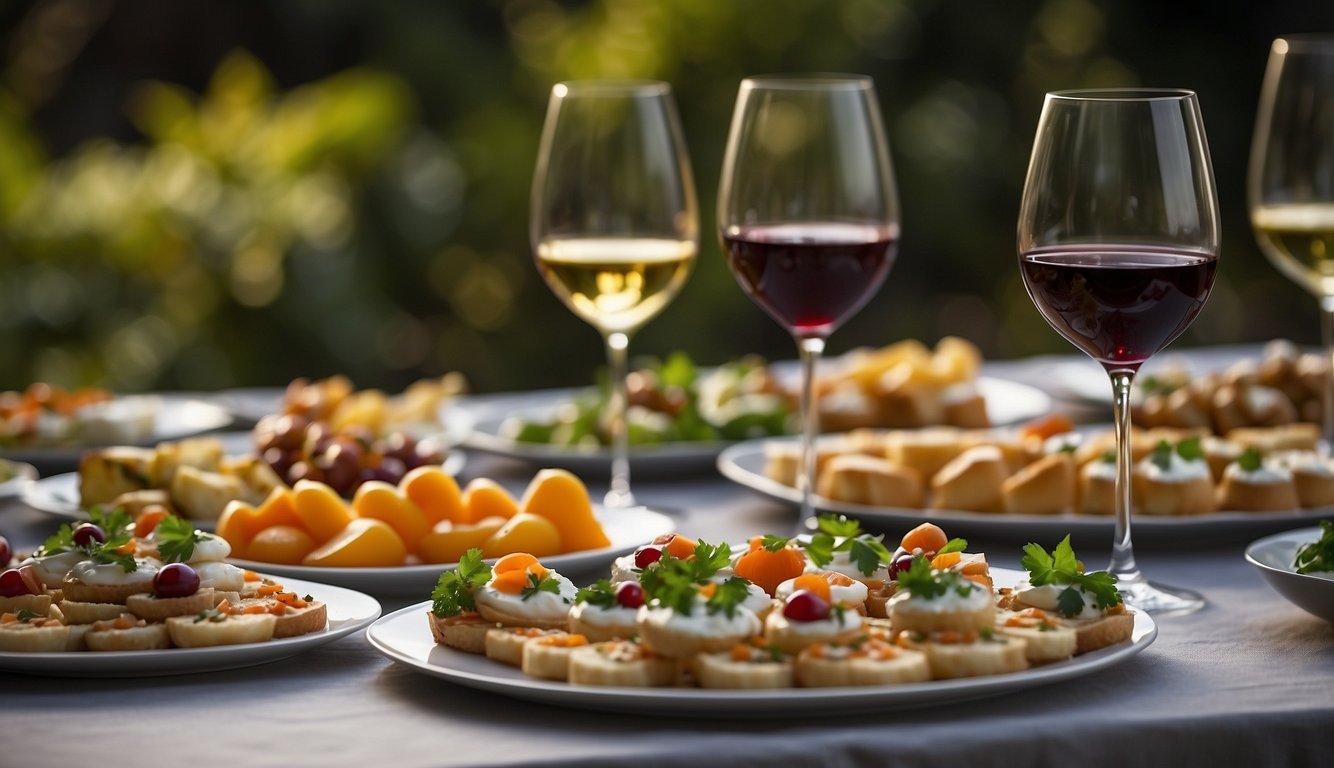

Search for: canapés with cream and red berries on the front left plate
xmin=0 ymin=509 xmax=327 ymax=652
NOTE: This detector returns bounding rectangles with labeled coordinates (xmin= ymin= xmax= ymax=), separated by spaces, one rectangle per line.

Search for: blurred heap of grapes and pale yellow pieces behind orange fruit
xmin=253 ymin=373 xmax=467 ymax=497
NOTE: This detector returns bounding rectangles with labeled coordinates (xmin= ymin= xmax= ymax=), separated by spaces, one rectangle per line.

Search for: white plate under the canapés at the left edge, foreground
xmin=0 ymin=579 xmax=380 ymax=677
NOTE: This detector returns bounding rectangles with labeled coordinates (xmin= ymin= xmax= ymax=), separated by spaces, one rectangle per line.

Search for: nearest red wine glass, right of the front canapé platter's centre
xmin=1018 ymin=89 xmax=1219 ymax=613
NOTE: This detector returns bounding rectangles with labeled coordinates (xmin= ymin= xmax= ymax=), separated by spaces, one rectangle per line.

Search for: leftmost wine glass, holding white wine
xmin=530 ymin=80 xmax=699 ymax=508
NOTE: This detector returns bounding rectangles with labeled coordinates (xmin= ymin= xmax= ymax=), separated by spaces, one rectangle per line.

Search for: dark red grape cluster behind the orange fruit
xmin=255 ymin=413 xmax=444 ymax=497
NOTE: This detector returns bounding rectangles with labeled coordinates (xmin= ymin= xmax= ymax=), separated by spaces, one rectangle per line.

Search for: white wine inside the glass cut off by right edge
xmin=1251 ymin=203 xmax=1334 ymax=299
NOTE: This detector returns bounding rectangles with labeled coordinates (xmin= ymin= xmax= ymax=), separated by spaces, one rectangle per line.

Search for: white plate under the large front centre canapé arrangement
xmin=366 ymin=568 xmax=1158 ymax=719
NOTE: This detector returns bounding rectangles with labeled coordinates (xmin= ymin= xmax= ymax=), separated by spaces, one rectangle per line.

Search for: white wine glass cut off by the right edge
xmin=1247 ymin=35 xmax=1334 ymax=442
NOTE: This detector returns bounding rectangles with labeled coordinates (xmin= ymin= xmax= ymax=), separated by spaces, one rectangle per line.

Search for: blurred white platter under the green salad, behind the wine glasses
xmin=444 ymin=376 xmax=1051 ymax=477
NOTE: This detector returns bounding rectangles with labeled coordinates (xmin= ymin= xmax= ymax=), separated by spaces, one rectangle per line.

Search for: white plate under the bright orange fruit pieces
xmin=229 ymin=507 xmax=676 ymax=597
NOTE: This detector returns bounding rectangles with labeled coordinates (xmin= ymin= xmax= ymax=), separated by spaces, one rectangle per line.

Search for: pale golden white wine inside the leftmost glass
xmin=538 ymin=237 xmax=695 ymax=333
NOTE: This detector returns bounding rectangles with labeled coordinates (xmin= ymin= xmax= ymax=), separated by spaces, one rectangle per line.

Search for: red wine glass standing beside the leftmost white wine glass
xmin=718 ymin=75 xmax=899 ymax=520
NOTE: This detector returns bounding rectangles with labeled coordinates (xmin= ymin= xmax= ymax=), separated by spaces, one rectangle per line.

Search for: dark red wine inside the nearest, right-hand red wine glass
xmin=1019 ymin=245 xmax=1218 ymax=369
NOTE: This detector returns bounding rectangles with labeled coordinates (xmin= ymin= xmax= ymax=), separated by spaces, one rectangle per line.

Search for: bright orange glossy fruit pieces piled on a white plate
xmin=217 ymin=467 xmax=611 ymax=568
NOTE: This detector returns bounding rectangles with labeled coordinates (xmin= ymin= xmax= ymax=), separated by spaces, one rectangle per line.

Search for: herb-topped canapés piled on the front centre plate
xmin=427 ymin=516 xmax=1134 ymax=689
